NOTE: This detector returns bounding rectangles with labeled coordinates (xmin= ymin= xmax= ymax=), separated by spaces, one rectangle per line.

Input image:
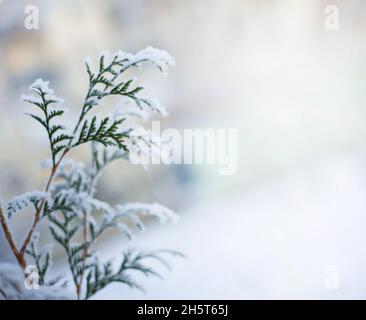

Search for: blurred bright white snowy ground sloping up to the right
xmin=96 ymin=156 xmax=366 ymax=299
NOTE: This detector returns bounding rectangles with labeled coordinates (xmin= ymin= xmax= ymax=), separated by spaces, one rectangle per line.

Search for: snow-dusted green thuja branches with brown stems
xmin=0 ymin=47 xmax=180 ymax=299
